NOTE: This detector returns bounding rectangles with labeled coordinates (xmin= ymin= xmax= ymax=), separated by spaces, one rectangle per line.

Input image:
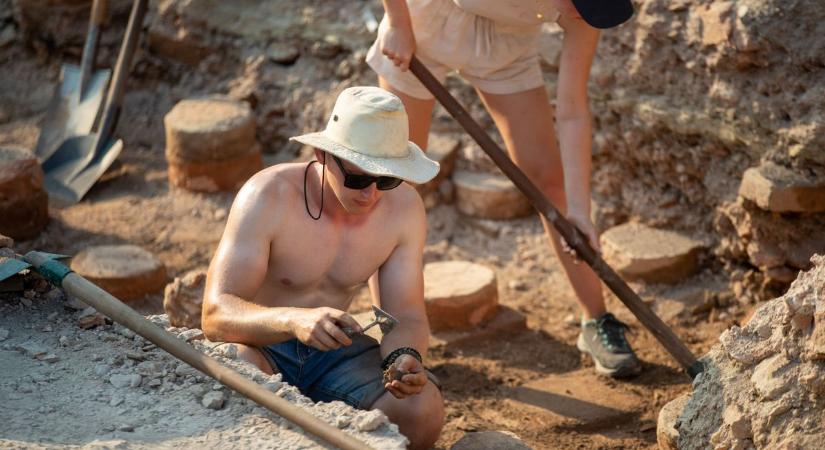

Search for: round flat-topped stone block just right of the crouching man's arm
xmin=424 ymin=261 xmax=498 ymax=332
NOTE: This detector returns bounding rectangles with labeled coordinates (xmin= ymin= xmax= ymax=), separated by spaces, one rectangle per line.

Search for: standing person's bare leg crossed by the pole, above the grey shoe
xmin=479 ymin=87 xmax=605 ymax=319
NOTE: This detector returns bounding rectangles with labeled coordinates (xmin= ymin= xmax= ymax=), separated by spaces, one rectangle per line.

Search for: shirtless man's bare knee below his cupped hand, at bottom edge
xmin=372 ymin=383 xmax=444 ymax=449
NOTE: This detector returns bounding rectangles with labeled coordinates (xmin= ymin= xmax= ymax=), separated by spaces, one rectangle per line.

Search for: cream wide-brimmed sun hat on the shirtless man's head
xmin=290 ymin=86 xmax=439 ymax=184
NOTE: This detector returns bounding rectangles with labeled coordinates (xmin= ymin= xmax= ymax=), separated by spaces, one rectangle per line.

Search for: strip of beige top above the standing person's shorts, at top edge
xmin=453 ymin=0 xmax=559 ymax=26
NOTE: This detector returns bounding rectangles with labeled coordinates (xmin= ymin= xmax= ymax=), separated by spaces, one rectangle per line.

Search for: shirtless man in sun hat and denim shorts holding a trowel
xmin=202 ymin=87 xmax=444 ymax=448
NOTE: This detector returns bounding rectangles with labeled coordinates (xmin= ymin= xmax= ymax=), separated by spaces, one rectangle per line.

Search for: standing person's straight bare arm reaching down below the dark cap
xmin=556 ymin=15 xmax=599 ymax=248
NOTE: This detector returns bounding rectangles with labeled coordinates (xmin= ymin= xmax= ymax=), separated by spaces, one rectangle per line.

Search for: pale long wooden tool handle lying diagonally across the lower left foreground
xmin=24 ymin=252 xmax=370 ymax=450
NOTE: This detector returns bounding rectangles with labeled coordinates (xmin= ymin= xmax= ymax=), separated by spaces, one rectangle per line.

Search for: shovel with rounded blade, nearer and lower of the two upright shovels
xmin=43 ymin=0 xmax=148 ymax=206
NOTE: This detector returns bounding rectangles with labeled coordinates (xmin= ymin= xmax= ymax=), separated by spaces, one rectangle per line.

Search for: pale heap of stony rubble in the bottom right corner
xmin=658 ymin=255 xmax=825 ymax=449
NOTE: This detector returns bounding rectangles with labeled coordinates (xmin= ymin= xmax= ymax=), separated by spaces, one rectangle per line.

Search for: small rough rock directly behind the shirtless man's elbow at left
xmin=163 ymin=270 xmax=206 ymax=328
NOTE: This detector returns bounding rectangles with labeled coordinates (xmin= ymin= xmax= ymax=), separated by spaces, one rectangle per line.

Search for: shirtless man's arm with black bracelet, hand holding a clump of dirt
xmin=378 ymin=190 xmax=430 ymax=398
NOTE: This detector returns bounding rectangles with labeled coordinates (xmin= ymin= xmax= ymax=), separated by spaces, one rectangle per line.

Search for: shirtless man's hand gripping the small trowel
xmin=290 ymin=307 xmax=362 ymax=352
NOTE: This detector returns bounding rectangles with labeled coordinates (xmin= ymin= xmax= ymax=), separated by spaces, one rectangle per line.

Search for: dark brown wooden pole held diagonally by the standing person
xmin=410 ymin=56 xmax=703 ymax=378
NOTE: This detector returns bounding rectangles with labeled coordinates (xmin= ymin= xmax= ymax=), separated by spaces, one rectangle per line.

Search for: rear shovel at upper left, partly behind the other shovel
xmin=34 ymin=0 xmax=110 ymax=161
